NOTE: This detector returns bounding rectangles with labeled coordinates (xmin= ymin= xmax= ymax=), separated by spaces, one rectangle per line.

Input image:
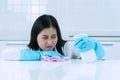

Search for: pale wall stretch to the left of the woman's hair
xmin=0 ymin=0 xmax=31 ymax=40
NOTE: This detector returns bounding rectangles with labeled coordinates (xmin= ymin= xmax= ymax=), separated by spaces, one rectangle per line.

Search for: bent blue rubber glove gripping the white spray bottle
xmin=74 ymin=36 xmax=105 ymax=59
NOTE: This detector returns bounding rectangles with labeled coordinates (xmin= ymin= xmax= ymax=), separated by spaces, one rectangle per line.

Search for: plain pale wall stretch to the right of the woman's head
xmin=48 ymin=0 xmax=120 ymax=36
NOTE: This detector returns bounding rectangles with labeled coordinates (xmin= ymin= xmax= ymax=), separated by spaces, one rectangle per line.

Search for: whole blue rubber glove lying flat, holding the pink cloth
xmin=20 ymin=50 xmax=64 ymax=61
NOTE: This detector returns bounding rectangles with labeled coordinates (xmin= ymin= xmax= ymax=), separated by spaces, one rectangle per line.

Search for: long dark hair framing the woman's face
xmin=28 ymin=14 xmax=66 ymax=55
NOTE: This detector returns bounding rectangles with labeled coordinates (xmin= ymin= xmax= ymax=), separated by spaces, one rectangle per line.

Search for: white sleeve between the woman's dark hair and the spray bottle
xmin=63 ymin=41 xmax=81 ymax=59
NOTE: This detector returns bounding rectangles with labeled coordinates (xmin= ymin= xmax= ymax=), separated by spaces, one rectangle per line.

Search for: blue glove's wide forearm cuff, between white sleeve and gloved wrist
xmin=20 ymin=50 xmax=41 ymax=61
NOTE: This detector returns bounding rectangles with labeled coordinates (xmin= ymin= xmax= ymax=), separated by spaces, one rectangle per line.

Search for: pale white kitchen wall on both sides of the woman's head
xmin=0 ymin=0 xmax=120 ymax=40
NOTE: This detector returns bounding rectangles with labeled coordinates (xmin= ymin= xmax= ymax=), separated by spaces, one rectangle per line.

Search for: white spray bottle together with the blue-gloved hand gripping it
xmin=73 ymin=34 xmax=97 ymax=63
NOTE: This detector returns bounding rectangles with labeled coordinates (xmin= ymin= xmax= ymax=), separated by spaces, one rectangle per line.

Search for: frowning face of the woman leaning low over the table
xmin=37 ymin=27 xmax=58 ymax=51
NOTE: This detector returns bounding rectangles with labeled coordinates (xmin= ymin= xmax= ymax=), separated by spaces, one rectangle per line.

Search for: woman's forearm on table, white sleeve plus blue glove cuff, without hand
xmin=1 ymin=48 xmax=41 ymax=61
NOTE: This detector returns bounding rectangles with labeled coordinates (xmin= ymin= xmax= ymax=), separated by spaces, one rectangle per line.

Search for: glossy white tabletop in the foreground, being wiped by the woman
xmin=0 ymin=59 xmax=120 ymax=80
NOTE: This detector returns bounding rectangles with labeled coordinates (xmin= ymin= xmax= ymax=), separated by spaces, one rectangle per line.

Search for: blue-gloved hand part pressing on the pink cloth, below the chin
xmin=41 ymin=51 xmax=64 ymax=59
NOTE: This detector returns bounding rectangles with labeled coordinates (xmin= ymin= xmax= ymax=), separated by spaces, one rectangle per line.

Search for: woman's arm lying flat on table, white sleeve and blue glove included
xmin=1 ymin=48 xmax=67 ymax=62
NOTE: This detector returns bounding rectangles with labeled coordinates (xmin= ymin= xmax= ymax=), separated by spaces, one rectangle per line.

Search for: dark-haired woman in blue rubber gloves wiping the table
xmin=2 ymin=14 xmax=105 ymax=61
